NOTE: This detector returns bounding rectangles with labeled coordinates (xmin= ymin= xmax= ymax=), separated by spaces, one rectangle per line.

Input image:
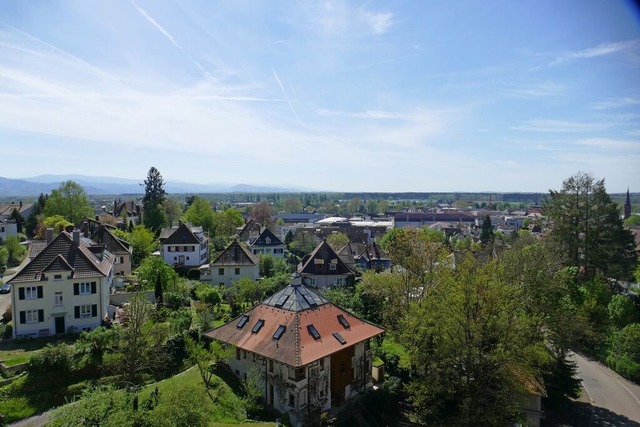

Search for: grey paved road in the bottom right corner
xmin=573 ymin=354 xmax=640 ymax=427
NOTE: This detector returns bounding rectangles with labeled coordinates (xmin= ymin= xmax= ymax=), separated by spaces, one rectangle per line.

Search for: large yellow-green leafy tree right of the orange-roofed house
xmin=403 ymin=255 xmax=548 ymax=426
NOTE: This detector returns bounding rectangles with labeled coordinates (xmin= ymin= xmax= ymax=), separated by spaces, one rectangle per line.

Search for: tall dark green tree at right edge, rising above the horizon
xmin=543 ymin=172 xmax=637 ymax=280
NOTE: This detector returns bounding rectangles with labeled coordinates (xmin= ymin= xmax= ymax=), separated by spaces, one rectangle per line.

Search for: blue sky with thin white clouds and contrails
xmin=0 ymin=0 xmax=640 ymax=192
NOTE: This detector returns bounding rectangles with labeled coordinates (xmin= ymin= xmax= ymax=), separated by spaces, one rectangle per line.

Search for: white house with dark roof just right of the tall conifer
xmin=160 ymin=222 xmax=209 ymax=267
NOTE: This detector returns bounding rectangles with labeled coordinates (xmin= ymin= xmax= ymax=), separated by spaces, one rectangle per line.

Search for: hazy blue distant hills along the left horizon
xmin=0 ymin=175 xmax=310 ymax=198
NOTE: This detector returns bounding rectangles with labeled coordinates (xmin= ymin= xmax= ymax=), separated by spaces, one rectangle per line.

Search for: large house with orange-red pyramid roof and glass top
xmin=205 ymin=285 xmax=384 ymax=425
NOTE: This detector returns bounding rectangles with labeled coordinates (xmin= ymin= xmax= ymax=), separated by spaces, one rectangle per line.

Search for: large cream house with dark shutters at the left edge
xmin=9 ymin=230 xmax=114 ymax=338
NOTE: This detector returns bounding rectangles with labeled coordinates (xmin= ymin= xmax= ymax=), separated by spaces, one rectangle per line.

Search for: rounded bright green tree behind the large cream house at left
xmin=44 ymin=181 xmax=93 ymax=224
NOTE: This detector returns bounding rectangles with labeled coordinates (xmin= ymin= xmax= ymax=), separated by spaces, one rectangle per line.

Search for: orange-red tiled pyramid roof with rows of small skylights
xmin=205 ymin=285 xmax=384 ymax=367
